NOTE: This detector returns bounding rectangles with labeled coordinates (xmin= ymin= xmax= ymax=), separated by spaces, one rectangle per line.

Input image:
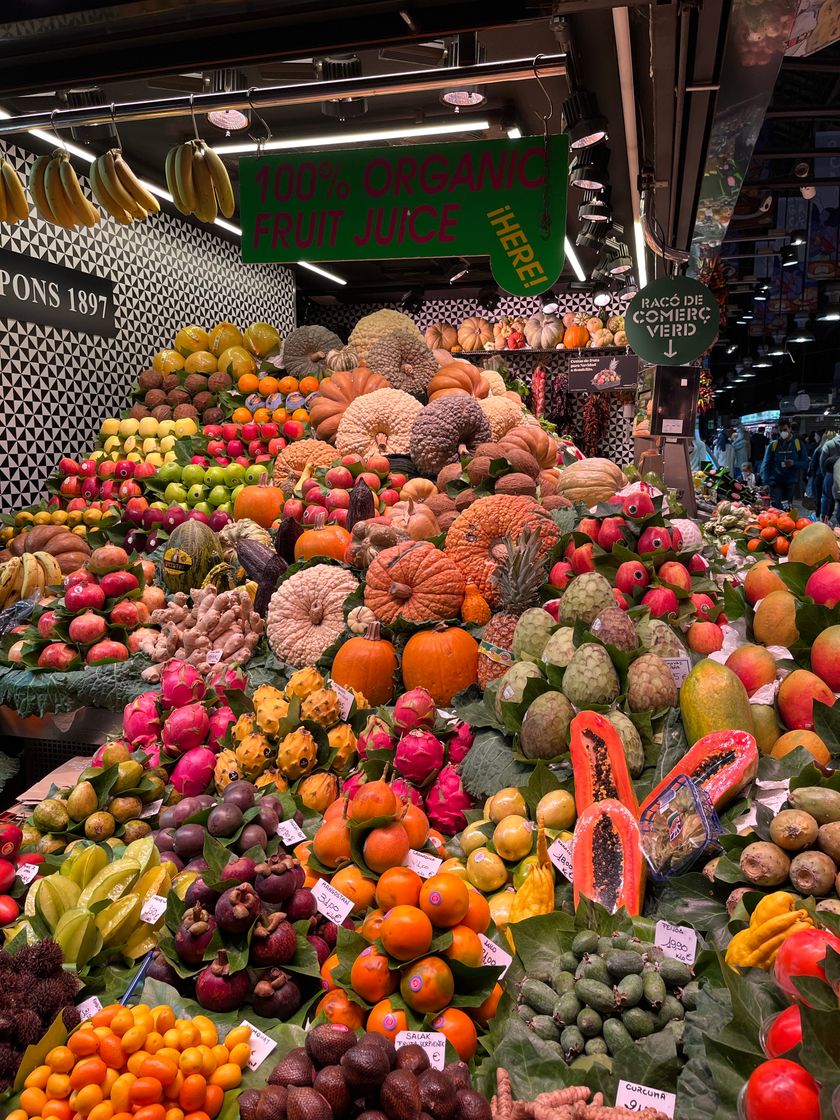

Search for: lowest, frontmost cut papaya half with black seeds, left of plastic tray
xmin=571 ymin=797 xmax=645 ymax=915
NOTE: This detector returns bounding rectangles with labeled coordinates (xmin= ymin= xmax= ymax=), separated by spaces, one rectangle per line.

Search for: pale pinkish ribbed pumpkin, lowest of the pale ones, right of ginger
xmin=267 ymin=564 xmax=358 ymax=669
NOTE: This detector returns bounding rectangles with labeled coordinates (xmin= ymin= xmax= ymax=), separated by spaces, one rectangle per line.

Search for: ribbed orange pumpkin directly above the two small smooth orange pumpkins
xmin=365 ymin=541 xmax=465 ymax=625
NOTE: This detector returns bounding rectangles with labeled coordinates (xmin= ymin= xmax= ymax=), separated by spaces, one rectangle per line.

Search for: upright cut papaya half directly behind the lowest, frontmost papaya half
xmin=569 ymin=711 xmax=638 ymax=819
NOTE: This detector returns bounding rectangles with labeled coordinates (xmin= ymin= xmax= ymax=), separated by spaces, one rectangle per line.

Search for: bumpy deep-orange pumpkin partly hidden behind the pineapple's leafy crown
xmin=446 ymin=494 xmax=560 ymax=607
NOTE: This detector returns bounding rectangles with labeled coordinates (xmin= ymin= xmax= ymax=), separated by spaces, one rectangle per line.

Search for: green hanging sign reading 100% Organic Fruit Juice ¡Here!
xmin=240 ymin=136 xmax=569 ymax=296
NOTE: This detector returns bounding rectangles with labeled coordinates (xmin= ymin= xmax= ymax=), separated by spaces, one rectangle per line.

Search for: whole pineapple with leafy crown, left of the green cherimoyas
xmin=478 ymin=529 xmax=545 ymax=689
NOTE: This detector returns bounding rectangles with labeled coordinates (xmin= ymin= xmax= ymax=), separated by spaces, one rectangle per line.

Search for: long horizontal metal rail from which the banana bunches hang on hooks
xmin=0 ymin=54 xmax=566 ymax=136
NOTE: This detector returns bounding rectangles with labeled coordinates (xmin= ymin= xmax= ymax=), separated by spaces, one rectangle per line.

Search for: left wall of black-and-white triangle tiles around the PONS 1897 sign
xmin=0 ymin=144 xmax=296 ymax=511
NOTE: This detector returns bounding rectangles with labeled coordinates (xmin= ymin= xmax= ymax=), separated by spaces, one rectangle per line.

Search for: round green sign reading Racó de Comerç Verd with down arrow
xmin=624 ymin=277 xmax=720 ymax=365
